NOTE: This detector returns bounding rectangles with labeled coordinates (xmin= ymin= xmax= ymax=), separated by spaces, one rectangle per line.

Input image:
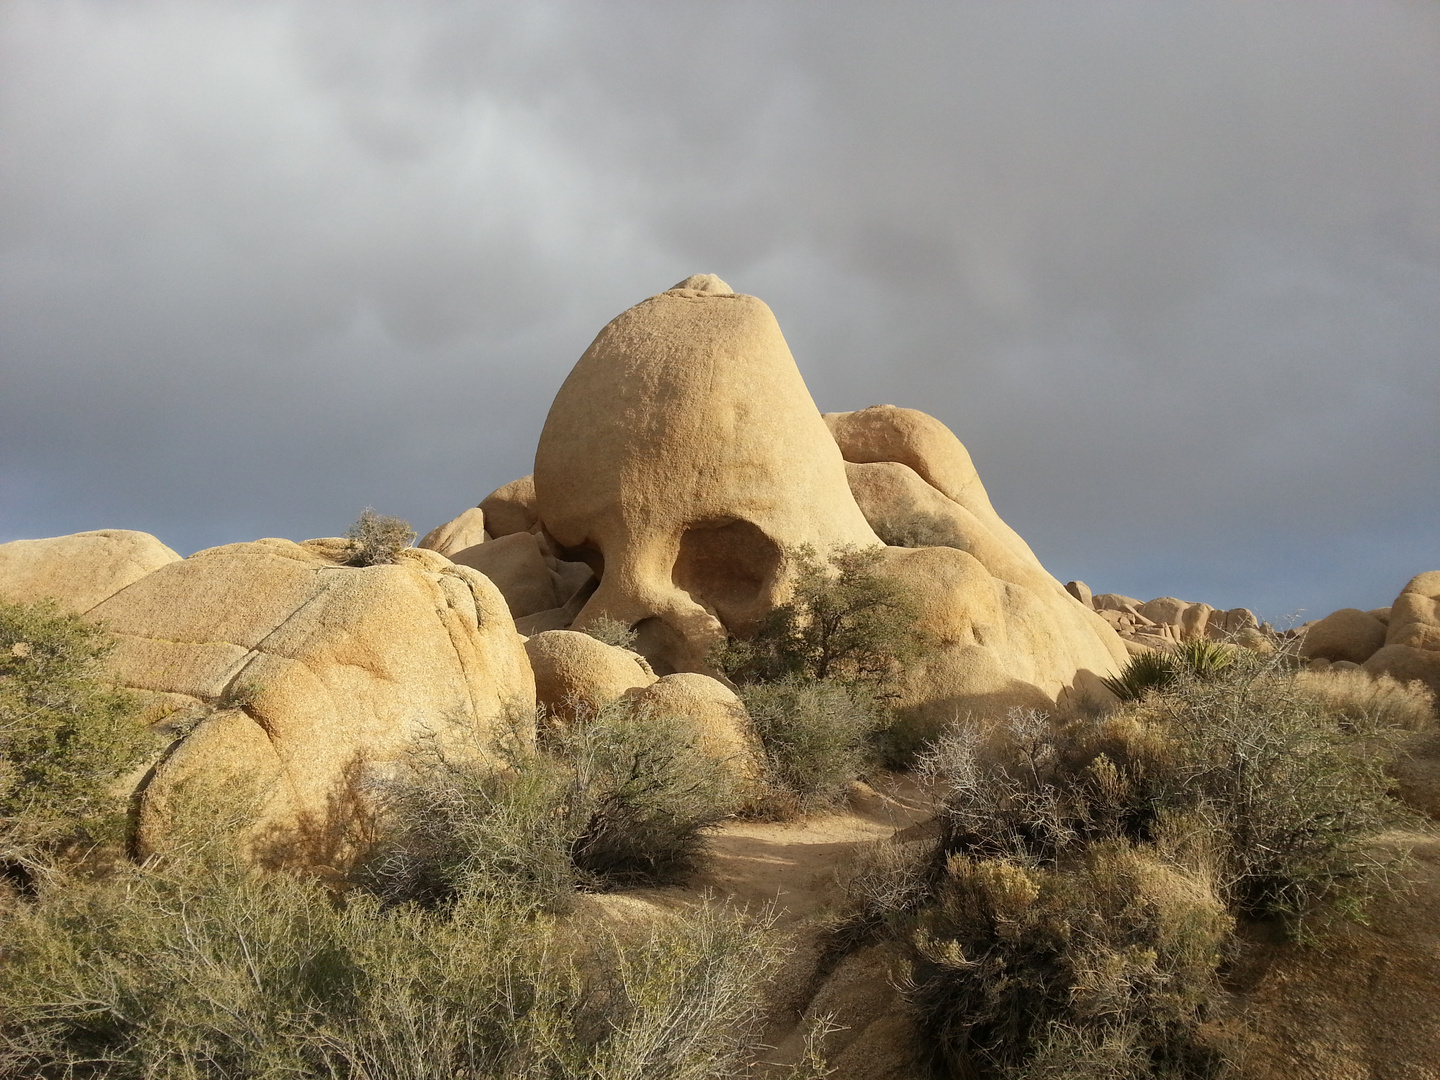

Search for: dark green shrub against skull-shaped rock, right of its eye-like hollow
xmin=716 ymin=547 xmax=920 ymax=696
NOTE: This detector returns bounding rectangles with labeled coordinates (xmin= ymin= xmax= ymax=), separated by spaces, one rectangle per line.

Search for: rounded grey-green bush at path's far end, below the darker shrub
xmin=740 ymin=675 xmax=886 ymax=818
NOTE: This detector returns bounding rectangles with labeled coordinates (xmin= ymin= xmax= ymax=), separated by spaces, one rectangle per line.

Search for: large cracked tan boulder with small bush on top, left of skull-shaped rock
xmin=92 ymin=540 xmax=534 ymax=867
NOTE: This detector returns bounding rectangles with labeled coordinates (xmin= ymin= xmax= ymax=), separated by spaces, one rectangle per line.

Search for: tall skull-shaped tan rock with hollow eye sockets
xmin=535 ymin=275 xmax=878 ymax=671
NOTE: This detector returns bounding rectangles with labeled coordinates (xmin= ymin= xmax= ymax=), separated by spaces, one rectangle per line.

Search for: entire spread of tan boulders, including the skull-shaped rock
xmin=8 ymin=275 xmax=1440 ymax=867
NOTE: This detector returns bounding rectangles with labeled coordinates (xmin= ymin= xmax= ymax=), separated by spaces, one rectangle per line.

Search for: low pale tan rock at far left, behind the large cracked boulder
xmin=0 ymin=528 xmax=180 ymax=612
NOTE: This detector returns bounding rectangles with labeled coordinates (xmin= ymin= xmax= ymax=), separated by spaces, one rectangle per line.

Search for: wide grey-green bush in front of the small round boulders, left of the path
xmin=366 ymin=701 xmax=740 ymax=909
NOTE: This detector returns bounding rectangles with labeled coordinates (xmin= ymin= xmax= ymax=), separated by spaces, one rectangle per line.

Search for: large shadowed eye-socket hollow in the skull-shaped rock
xmin=671 ymin=520 xmax=783 ymax=636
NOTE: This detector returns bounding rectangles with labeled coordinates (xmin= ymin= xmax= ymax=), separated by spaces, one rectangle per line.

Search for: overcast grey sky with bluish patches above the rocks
xmin=0 ymin=0 xmax=1440 ymax=619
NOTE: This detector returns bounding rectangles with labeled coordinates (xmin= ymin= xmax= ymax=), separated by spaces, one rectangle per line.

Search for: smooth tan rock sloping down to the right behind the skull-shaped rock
xmin=825 ymin=405 xmax=1128 ymax=723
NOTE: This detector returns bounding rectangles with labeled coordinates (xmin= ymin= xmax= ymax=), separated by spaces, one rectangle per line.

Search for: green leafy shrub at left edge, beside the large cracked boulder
xmin=0 ymin=600 xmax=154 ymax=868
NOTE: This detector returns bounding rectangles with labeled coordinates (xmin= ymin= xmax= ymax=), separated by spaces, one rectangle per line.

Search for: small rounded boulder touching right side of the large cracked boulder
xmin=526 ymin=629 xmax=655 ymax=723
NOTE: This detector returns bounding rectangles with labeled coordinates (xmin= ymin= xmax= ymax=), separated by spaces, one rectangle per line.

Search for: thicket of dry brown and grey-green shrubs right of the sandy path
xmin=828 ymin=649 xmax=1434 ymax=1080
